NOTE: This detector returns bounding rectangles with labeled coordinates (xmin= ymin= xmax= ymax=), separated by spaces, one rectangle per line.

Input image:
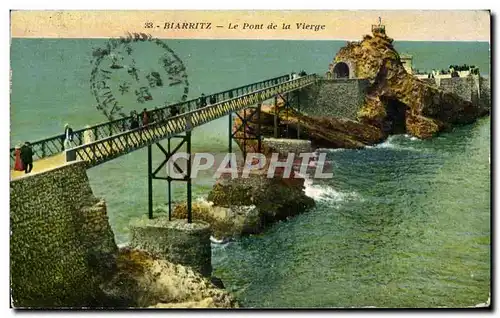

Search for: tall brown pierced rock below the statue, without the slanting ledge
xmin=330 ymin=32 xmax=488 ymax=138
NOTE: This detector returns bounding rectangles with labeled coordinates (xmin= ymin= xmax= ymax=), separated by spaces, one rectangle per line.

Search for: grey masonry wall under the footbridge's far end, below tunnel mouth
xmin=299 ymin=79 xmax=369 ymax=120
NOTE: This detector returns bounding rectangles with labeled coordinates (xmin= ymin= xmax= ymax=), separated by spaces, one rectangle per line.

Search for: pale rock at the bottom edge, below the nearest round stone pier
xmin=101 ymin=248 xmax=238 ymax=308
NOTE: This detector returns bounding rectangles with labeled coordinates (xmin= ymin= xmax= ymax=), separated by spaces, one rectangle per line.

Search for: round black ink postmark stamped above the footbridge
xmin=90 ymin=33 xmax=189 ymax=120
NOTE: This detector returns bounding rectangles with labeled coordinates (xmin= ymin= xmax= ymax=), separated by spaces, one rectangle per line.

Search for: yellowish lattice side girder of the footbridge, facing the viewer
xmin=66 ymin=74 xmax=316 ymax=167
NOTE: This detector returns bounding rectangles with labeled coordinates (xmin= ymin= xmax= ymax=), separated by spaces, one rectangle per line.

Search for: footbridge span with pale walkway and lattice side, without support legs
xmin=11 ymin=74 xmax=316 ymax=178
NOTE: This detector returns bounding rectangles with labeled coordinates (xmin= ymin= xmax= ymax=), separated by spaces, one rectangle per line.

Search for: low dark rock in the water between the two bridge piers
xmin=173 ymin=170 xmax=314 ymax=239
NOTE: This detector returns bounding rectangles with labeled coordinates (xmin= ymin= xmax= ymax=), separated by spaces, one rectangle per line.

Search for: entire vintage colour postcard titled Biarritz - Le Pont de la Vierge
xmin=10 ymin=10 xmax=492 ymax=309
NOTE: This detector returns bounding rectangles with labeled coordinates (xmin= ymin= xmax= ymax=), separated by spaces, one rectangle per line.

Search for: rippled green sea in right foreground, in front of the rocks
xmin=213 ymin=119 xmax=491 ymax=307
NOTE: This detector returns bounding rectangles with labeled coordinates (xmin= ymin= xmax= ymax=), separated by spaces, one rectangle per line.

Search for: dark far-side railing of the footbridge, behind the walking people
xmin=10 ymin=74 xmax=290 ymax=166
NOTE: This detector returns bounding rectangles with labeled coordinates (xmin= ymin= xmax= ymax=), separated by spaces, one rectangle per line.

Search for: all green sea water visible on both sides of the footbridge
xmin=11 ymin=39 xmax=490 ymax=307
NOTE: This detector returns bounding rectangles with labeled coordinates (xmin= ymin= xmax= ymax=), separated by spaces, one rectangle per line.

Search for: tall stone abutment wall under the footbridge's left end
xmin=10 ymin=162 xmax=117 ymax=307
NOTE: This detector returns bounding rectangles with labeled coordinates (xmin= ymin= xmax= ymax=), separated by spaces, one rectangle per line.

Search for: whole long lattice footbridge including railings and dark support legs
xmin=10 ymin=74 xmax=317 ymax=222
